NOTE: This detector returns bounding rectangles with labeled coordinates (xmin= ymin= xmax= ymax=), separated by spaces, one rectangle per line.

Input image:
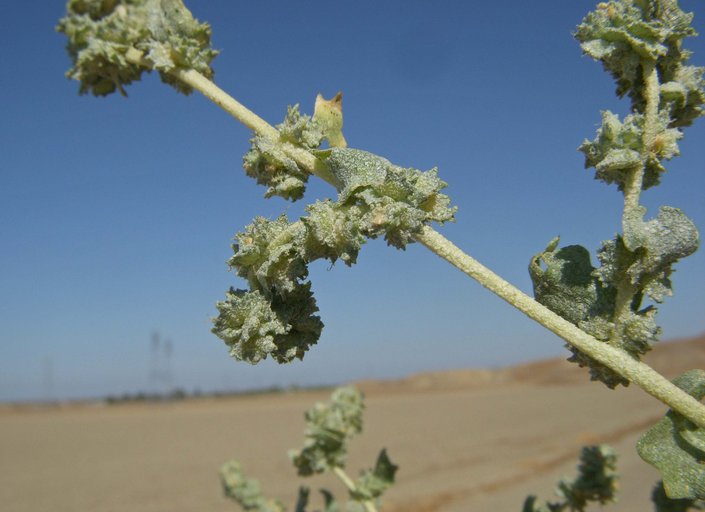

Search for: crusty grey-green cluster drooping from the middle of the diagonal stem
xmin=213 ymin=106 xmax=455 ymax=363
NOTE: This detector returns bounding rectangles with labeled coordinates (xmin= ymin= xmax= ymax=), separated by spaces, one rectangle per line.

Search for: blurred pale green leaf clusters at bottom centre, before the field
xmin=220 ymin=386 xmax=397 ymax=512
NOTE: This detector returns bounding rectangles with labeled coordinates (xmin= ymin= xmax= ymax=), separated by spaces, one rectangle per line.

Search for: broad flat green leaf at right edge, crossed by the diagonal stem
xmin=637 ymin=370 xmax=705 ymax=500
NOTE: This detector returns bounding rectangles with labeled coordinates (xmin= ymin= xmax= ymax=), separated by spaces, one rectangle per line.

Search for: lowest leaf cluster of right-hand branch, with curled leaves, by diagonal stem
xmin=529 ymin=206 xmax=699 ymax=388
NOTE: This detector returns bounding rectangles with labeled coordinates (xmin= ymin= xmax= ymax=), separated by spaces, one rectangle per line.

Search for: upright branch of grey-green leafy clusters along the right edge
xmin=529 ymin=0 xmax=705 ymax=388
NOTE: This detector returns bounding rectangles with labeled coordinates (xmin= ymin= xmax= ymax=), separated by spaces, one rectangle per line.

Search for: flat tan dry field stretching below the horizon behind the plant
xmin=0 ymin=337 xmax=705 ymax=512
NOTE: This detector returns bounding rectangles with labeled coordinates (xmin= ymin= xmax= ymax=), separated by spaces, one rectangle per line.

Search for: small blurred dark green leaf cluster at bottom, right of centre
xmin=522 ymin=445 xmax=618 ymax=512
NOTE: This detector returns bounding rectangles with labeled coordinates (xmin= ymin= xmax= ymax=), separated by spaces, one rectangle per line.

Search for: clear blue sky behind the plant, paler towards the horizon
xmin=0 ymin=0 xmax=705 ymax=401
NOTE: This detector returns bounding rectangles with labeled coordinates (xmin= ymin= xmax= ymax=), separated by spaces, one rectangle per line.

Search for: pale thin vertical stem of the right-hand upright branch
xmin=612 ymin=60 xmax=661 ymax=332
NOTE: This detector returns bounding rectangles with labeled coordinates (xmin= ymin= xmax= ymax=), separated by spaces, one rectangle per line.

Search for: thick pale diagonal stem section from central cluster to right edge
xmin=416 ymin=227 xmax=705 ymax=428
